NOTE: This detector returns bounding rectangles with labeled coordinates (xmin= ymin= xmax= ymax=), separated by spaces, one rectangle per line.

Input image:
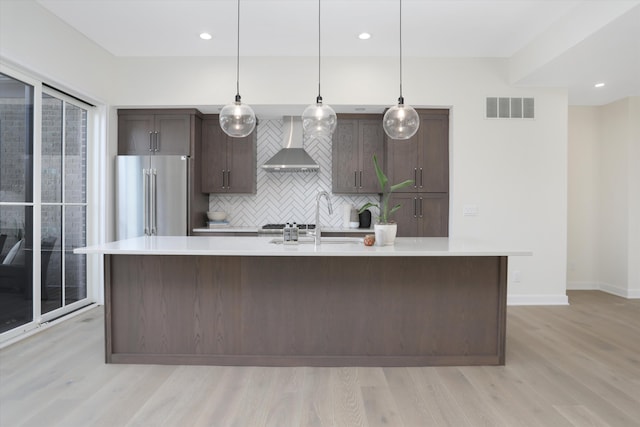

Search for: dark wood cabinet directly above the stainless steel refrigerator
xmin=118 ymin=109 xmax=201 ymax=156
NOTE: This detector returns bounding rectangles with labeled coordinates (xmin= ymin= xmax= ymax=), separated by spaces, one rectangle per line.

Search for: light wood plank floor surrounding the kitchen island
xmin=0 ymin=291 xmax=640 ymax=427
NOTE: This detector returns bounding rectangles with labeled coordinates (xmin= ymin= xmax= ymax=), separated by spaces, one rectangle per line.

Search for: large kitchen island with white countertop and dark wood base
xmin=75 ymin=237 xmax=530 ymax=366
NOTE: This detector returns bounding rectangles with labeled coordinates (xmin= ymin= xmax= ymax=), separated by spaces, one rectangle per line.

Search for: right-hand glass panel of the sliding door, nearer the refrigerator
xmin=40 ymin=93 xmax=87 ymax=313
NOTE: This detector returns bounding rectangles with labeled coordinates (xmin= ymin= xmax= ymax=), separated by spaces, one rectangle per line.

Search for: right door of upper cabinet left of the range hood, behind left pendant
xmin=225 ymin=131 xmax=257 ymax=193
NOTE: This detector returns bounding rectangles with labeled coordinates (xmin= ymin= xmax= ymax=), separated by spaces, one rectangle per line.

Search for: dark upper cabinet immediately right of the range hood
xmin=332 ymin=114 xmax=384 ymax=194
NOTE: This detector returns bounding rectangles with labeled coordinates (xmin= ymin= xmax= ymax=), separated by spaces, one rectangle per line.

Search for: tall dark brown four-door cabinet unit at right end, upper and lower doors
xmin=385 ymin=109 xmax=449 ymax=237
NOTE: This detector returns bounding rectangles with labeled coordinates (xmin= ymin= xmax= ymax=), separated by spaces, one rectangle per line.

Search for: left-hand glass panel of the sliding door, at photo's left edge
xmin=0 ymin=74 xmax=34 ymax=333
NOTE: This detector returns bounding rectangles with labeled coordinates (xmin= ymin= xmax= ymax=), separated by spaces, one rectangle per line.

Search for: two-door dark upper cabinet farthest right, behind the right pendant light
xmin=386 ymin=109 xmax=449 ymax=193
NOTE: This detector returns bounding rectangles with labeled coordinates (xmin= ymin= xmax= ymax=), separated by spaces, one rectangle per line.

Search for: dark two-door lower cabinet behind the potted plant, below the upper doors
xmin=390 ymin=193 xmax=449 ymax=237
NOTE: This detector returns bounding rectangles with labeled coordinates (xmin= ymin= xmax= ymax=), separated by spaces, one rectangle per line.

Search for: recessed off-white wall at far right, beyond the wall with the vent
xmin=567 ymin=97 xmax=640 ymax=298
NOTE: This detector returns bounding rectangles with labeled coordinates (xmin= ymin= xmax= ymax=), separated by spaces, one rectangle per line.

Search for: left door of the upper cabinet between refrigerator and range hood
xmin=200 ymin=116 xmax=227 ymax=193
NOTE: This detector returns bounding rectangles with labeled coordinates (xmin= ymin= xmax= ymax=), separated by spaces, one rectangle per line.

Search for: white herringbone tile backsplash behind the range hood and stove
xmin=209 ymin=120 xmax=377 ymax=227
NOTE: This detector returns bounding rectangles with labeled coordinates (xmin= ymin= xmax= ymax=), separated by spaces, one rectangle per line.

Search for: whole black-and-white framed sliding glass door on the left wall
xmin=0 ymin=73 xmax=88 ymax=338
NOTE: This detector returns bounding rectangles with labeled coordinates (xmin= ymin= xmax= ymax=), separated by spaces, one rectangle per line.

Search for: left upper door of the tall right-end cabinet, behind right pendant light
xmin=386 ymin=130 xmax=420 ymax=193
